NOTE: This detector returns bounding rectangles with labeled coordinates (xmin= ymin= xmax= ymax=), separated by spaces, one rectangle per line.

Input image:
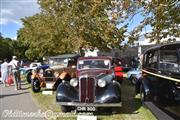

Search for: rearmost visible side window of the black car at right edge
xmin=160 ymin=50 xmax=180 ymax=72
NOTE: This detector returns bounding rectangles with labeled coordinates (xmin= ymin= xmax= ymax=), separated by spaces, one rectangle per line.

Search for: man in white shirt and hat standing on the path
xmin=9 ymin=56 xmax=21 ymax=90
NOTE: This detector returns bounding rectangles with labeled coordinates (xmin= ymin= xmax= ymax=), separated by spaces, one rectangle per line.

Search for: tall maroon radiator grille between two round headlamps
xmin=79 ymin=77 xmax=95 ymax=103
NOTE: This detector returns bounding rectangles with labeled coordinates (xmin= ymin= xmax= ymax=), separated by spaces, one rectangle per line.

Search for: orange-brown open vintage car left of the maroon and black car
xmin=31 ymin=54 xmax=79 ymax=92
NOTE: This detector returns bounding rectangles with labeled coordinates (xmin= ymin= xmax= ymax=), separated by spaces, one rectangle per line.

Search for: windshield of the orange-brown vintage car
xmin=49 ymin=58 xmax=68 ymax=66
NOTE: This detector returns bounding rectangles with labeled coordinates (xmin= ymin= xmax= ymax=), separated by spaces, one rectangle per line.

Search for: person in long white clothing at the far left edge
xmin=1 ymin=58 xmax=8 ymax=87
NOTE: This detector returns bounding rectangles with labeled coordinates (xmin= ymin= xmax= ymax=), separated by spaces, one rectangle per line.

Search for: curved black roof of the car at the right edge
xmin=145 ymin=43 xmax=180 ymax=53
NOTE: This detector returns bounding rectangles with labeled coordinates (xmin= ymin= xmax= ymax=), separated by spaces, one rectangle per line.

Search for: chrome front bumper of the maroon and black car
xmin=58 ymin=102 xmax=122 ymax=107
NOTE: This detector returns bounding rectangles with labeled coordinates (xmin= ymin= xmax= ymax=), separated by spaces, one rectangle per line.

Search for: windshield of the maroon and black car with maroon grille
xmin=78 ymin=59 xmax=111 ymax=70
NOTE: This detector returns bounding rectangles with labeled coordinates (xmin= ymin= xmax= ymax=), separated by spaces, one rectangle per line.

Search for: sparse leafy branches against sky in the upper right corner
xmin=129 ymin=0 xmax=180 ymax=43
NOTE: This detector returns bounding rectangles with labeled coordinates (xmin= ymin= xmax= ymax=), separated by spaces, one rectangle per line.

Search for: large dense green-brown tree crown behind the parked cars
xmin=18 ymin=0 xmax=126 ymax=59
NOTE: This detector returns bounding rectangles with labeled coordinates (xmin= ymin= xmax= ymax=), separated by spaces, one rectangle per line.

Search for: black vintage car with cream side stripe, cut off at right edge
xmin=136 ymin=43 xmax=180 ymax=105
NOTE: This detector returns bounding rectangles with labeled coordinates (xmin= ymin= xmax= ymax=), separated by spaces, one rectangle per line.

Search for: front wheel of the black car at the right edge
xmin=140 ymin=85 xmax=150 ymax=104
